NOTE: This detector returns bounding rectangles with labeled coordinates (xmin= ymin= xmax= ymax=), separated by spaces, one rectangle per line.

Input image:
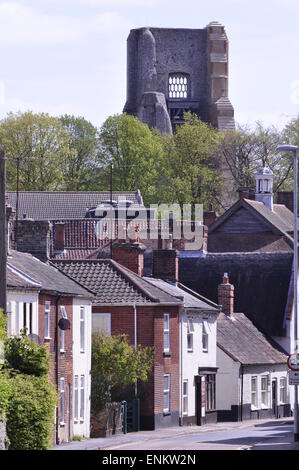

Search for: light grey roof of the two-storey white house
xmin=145 ymin=277 xmax=219 ymax=314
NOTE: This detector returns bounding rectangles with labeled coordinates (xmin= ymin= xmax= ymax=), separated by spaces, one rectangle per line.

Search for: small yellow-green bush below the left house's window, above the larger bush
xmin=5 ymin=333 xmax=50 ymax=377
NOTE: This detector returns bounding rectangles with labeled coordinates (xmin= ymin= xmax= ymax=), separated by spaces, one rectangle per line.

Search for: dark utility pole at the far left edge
xmin=0 ymin=149 xmax=7 ymax=313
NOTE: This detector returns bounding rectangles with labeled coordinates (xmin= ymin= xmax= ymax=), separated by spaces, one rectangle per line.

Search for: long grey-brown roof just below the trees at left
xmin=7 ymin=191 xmax=142 ymax=220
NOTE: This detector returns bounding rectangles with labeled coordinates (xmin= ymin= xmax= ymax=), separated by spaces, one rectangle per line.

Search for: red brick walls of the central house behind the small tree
xmin=92 ymin=306 xmax=179 ymax=426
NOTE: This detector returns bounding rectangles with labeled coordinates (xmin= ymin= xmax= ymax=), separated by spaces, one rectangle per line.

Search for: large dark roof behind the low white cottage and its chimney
xmin=179 ymin=253 xmax=293 ymax=336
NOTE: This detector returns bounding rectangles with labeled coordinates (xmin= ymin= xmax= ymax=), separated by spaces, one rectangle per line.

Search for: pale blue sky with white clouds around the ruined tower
xmin=0 ymin=0 xmax=299 ymax=128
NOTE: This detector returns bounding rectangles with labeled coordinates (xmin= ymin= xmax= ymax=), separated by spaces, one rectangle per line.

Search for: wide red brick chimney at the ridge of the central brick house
xmin=112 ymin=240 xmax=146 ymax=276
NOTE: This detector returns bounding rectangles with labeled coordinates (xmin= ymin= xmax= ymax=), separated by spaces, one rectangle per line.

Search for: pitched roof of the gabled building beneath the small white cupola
xmin=209 ymin=199 xmax=294 ymax=244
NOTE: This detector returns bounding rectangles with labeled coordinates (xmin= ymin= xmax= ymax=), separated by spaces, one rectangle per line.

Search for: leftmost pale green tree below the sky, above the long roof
xmin=0 ymin=112 xmax=72 ymax=191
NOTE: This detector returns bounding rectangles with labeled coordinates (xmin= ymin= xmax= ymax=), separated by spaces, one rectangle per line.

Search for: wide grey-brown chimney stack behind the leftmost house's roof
xmin=16 ymin=219 xmax=50 ymax=262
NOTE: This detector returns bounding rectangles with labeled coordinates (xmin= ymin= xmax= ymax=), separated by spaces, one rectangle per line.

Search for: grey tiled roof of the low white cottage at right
xmin=217 ymin=313 xmax=287 ymax=365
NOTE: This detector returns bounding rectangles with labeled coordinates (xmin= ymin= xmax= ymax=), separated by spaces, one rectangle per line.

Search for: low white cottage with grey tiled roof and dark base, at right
xmin=217 ymin=313 xmax=290 ymax=421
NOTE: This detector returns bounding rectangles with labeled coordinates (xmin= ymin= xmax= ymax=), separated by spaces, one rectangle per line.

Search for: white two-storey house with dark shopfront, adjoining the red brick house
xmin=147 ymin=278 xmax=219 ymax=425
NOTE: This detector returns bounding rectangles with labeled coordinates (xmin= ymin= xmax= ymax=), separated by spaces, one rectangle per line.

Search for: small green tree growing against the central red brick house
xmin=91 ymin=334 xmax=154 ymax=413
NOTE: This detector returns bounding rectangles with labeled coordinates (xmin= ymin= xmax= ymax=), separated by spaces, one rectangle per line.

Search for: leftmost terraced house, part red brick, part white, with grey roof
xmin=7 ymin=251 xmax=93 ymax=443
